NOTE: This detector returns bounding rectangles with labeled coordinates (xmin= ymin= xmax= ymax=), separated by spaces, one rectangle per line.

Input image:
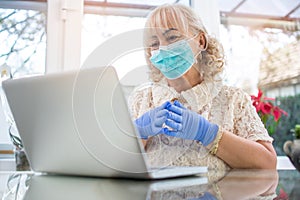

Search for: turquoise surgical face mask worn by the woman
xmin=150 ymin=39 xmax=195 ymax=79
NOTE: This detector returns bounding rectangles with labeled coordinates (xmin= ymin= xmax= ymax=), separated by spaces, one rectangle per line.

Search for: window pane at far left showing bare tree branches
xmin=0 ymin=2 xmax=46 ymax=143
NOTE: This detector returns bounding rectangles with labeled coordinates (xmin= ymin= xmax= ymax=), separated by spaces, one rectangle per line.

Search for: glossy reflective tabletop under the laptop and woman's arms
xmin=2 ymin=170 xmax=300 ymax=200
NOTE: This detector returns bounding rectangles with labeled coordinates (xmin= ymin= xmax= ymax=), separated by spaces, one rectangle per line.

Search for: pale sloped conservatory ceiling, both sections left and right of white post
xmin=84 ymin=0 xmax=300 ymax=31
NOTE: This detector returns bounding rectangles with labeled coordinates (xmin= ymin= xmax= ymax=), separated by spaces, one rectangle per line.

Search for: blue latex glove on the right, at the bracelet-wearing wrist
xmin=165 ymin=101 xmax=219 ymax=146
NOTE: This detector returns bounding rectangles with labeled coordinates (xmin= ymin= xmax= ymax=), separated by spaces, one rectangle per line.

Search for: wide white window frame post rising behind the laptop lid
xmin=46 ymin=0 xmax=83 ymax=73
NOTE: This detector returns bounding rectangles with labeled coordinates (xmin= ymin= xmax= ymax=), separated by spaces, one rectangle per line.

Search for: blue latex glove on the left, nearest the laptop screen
xmin=134 ymin=101 xmax=171 ymax=139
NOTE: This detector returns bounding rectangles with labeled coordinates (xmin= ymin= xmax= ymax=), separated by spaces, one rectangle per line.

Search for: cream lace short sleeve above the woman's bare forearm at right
xmin=234 ymin=90 xmax=273 ymax=142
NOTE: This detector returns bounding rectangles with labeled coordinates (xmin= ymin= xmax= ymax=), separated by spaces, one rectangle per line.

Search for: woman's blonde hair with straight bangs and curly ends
xmin=144 ymin=4 xmax=224 ymax=82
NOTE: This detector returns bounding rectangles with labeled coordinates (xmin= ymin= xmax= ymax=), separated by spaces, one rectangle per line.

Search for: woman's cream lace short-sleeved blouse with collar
xmin=128 ymin=79 xmax=273 ymax=170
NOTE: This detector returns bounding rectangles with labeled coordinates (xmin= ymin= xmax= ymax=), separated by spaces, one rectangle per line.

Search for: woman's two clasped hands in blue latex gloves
xmin=134 ymin=100 xmax=219 ymax=146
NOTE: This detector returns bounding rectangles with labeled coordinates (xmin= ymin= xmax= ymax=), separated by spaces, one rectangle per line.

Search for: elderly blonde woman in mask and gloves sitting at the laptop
xmin=129 ymin=4 xmax=277 ymax=169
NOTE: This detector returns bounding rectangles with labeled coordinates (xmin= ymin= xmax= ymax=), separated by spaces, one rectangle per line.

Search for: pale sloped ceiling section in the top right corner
xmin=217 ymin=0 xmax=300 ymax=31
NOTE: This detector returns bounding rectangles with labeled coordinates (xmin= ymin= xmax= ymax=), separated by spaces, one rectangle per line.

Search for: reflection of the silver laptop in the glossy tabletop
xmin=20 ymin=174 xmax=211 ymax=200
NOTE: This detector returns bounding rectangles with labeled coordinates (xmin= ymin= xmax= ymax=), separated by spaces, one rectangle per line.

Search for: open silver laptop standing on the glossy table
xmin=3 ymin=66 xmax=207 ymax=179
